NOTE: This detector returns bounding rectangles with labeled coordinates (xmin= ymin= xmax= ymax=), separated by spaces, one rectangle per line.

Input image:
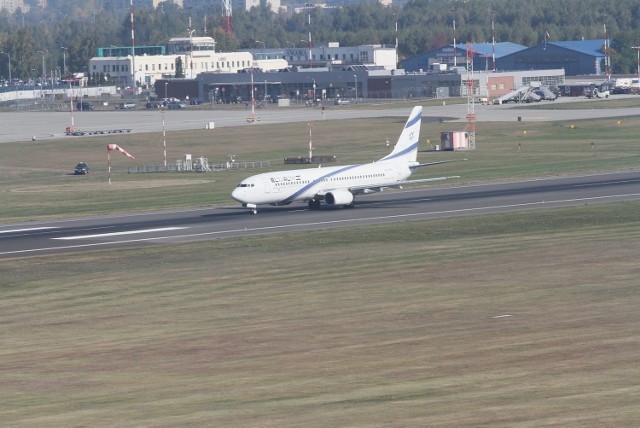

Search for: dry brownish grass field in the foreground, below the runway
xmin=0 ymin=204 xmax=640 ymax=427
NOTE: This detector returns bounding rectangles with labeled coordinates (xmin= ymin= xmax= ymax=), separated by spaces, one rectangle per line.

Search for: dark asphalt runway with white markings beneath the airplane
xmin=0 ymin=170 xmax=640 ymax=259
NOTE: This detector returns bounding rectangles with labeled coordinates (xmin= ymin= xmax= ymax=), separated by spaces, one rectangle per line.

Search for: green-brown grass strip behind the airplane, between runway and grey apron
xmin=0 ymin=112 xmax=640 ymax=224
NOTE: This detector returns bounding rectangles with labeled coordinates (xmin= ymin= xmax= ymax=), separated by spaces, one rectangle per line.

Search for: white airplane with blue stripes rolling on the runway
xmin=231 ymin=106 xmax=458 ymax=214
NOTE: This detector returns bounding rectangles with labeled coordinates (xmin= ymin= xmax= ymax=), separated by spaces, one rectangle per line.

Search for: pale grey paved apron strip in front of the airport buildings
xmin=0 ymin=98 xmax=640 ymax=143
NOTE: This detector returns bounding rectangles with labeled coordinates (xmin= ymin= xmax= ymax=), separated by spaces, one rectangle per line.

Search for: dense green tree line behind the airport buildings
xmin=0 ymin=0 xmax=640 ymax=78
